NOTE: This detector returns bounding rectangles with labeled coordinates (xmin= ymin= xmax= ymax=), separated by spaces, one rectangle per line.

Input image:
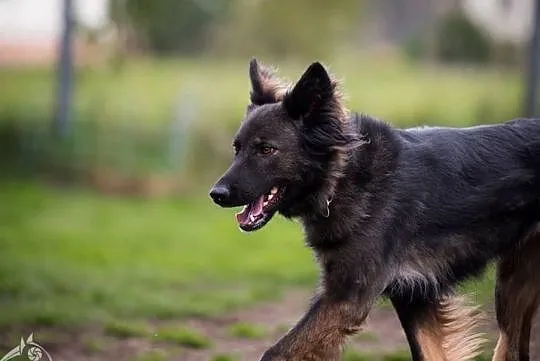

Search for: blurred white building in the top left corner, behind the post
xmin=0 ymin=0 xmax=109 ymax=65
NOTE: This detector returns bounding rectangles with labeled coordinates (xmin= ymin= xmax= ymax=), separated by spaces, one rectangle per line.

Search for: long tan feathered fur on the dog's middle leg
xmin=417 ymin=297 xmax=485 ymax=361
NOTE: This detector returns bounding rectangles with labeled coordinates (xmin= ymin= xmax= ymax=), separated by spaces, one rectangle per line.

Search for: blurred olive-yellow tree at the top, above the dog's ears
xmin=214 ymin=0 xmax=362 ymax=58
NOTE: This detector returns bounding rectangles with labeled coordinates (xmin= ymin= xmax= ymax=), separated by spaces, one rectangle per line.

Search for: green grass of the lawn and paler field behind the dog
xmin=0 ymin=58 xmax=521 ymax=361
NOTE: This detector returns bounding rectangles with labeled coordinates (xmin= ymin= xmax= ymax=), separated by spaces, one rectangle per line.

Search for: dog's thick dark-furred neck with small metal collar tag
xmin=299 ymin=116 xmax=399 ymax=247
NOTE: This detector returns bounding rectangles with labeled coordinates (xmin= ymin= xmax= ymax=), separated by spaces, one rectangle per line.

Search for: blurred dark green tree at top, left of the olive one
xmin=110 ymin=0 xmax=231 ymax=54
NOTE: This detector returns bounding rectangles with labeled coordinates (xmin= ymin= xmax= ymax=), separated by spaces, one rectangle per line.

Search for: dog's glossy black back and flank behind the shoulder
xmin=364 ymin=119 xmax=540 ymax=284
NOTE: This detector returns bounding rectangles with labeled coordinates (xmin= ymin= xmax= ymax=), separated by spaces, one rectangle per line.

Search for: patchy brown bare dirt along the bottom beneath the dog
xmin=0 ymin=291 xmax=540 ymax=361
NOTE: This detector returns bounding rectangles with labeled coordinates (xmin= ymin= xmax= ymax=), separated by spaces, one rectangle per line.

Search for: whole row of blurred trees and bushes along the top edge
xmin=103 ymin=0 xmax=524 ymax=66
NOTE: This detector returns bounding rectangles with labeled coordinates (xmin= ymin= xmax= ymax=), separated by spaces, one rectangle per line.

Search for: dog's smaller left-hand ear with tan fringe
xmin=249 ymin=58 xmax=288 ymax=105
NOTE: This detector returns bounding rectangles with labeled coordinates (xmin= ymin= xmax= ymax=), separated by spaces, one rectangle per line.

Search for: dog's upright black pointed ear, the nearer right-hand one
xmin=283 ymin=62 xmax=334 ymax=119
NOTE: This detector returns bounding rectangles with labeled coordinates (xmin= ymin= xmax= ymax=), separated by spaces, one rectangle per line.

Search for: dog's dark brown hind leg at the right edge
xmin=493 ymin=234 xmax=540 ymax=361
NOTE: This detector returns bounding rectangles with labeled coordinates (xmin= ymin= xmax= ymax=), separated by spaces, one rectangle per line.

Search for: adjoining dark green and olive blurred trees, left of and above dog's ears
xmin=110 ymin=0 xmax=363 ymax=57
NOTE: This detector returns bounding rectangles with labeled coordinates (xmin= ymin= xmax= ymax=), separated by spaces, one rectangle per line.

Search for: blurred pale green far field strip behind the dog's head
xmin=0 ymin=55 xmax=521 ymax=180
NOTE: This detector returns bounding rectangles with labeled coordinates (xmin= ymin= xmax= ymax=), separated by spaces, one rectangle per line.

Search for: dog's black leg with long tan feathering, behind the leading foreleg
xmin=391 ymin=296 xmax=483 ymax=361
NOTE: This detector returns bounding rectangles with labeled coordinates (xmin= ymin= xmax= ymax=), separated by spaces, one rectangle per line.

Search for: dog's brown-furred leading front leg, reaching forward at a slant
xmin=261 ymin=287 xmax=379 ymax=361
